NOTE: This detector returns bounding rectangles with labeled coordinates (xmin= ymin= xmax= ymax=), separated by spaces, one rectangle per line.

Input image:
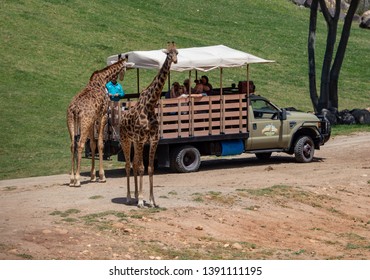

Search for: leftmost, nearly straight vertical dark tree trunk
xmin=308 ymin=0 xmax=319 ymax=113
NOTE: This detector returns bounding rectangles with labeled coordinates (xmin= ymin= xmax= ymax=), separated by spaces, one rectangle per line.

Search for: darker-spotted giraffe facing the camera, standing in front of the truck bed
xmin=120 ymin=42 xmax=177 ymax=208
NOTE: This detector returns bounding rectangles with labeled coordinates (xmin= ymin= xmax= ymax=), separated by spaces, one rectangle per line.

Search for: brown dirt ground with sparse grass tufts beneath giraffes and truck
xmin=0 ymin=133 xmax=370 ymax=260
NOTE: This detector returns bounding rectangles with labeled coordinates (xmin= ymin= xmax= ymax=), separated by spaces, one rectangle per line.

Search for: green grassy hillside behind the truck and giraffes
xmin=0 ymin=0 xmax=370 ymax=179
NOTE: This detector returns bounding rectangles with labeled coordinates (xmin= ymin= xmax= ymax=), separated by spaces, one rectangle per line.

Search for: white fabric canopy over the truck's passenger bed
xmin=107 ymin=45 xmax=274 ymax=72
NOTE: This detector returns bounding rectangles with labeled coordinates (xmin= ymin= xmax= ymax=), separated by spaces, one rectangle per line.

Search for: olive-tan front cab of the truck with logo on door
xmin=246 ymin=95 xmax=330 ymax=162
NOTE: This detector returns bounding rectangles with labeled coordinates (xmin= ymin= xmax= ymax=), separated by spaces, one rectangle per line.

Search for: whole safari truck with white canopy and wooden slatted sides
xmin=94 ymin=45 xmax=330 ymax=173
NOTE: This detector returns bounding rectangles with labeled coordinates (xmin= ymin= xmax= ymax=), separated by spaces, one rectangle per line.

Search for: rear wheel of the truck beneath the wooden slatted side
xmin=170 ymin=145 xmax=200 ymax=173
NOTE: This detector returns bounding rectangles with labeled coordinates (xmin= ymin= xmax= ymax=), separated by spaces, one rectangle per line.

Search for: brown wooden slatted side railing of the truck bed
xmin=120 ymin=94 xmax=248 ymax=139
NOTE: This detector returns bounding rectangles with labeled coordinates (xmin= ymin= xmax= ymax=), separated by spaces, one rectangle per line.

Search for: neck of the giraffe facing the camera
xmin=143 ymin=54 xmax=172 ymax=106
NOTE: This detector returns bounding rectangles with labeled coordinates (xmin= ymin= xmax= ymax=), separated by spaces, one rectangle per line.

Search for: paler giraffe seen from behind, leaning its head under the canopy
xmin=67 ymin=55 xmax=127 ymax=187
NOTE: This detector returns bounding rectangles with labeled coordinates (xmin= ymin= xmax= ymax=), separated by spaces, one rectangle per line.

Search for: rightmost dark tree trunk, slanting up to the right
xmin=329 ymin=0 xmax=360 ymax=108
